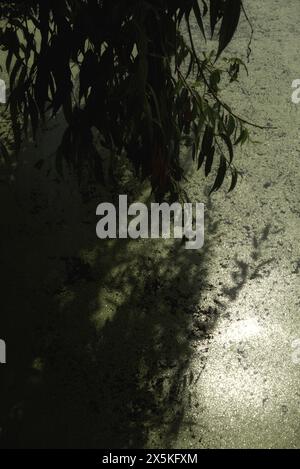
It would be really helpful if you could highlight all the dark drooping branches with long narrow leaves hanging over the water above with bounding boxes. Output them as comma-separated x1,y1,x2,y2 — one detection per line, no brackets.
0,0,248,198
